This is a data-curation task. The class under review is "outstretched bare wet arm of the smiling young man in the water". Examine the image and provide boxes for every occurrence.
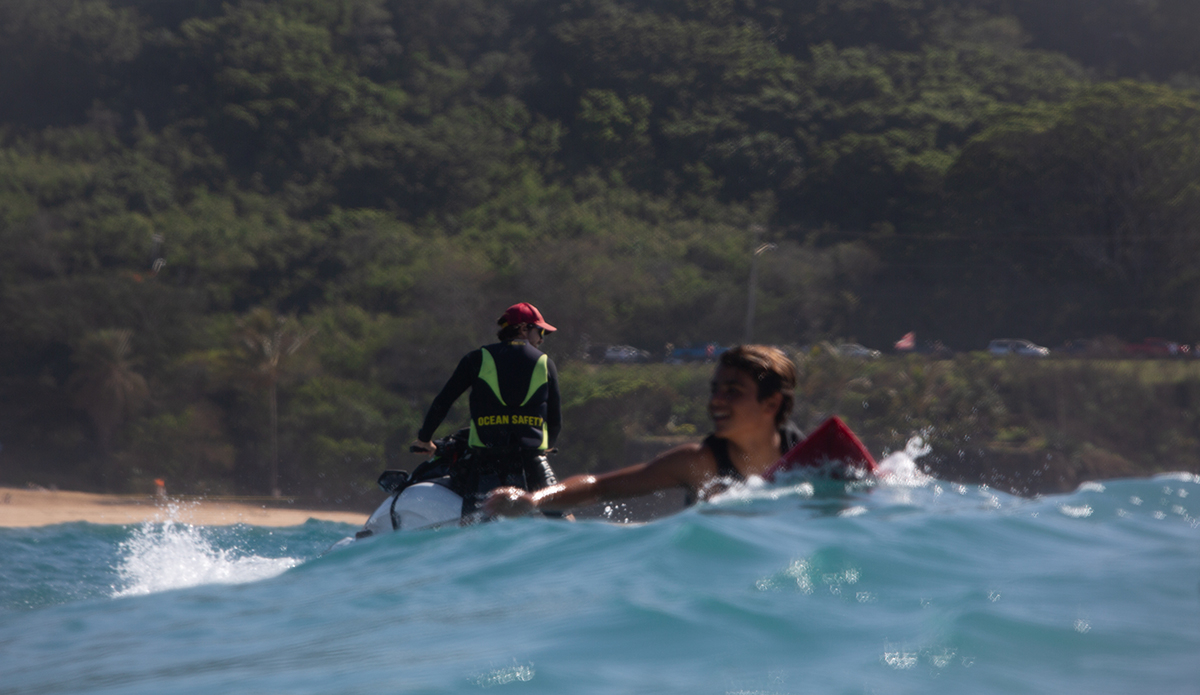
[484,444,716,516]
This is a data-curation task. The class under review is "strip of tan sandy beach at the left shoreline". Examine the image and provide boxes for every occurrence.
[0,487,366,527]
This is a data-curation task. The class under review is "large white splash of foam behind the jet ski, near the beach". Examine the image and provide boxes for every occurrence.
[113,511,300,597]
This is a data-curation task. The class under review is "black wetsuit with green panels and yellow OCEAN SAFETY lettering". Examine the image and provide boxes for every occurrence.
[416,341,563,515]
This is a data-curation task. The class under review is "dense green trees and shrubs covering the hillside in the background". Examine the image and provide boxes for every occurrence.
[0,0,1200,501]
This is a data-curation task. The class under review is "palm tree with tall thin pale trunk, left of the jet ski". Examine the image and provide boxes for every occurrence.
[238,307,317,497]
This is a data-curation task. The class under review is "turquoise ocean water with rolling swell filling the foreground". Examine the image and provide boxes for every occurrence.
[0,453,1200,695]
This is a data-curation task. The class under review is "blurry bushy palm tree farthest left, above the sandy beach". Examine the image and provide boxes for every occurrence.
[67,330,150,487]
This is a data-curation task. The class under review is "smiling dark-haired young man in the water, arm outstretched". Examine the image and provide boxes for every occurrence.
[484,344,802,516]
